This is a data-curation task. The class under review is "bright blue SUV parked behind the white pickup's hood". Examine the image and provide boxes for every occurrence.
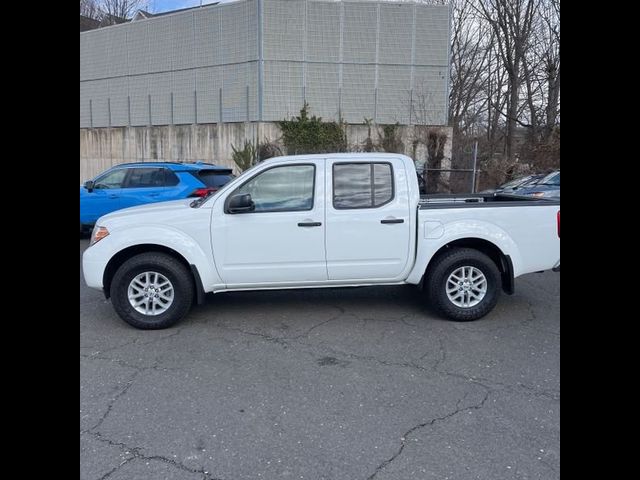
[80,162,234,232]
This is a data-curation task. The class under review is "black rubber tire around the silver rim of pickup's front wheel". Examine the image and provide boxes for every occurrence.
[111,252,194,330]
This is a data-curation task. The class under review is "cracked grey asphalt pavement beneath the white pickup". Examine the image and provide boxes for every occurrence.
[80,240,560,480]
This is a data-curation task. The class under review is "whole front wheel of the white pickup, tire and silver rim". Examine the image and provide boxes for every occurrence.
[111,252,194,330]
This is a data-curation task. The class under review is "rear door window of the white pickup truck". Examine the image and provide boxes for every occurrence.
[333,163,393,209]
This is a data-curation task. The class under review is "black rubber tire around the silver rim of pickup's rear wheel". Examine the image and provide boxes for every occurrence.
[425,248,500,322]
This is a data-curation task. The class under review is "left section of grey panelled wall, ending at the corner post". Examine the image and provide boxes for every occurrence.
[80,0,258,127]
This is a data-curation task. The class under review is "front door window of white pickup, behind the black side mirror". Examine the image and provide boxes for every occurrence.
[234,165,315,212]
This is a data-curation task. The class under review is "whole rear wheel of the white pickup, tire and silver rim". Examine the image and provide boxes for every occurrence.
[426,248,500,322]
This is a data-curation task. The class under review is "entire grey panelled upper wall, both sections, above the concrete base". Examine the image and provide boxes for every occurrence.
[80,0,449,128]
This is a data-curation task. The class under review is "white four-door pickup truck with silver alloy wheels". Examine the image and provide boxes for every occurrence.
[83,153,560,329]
